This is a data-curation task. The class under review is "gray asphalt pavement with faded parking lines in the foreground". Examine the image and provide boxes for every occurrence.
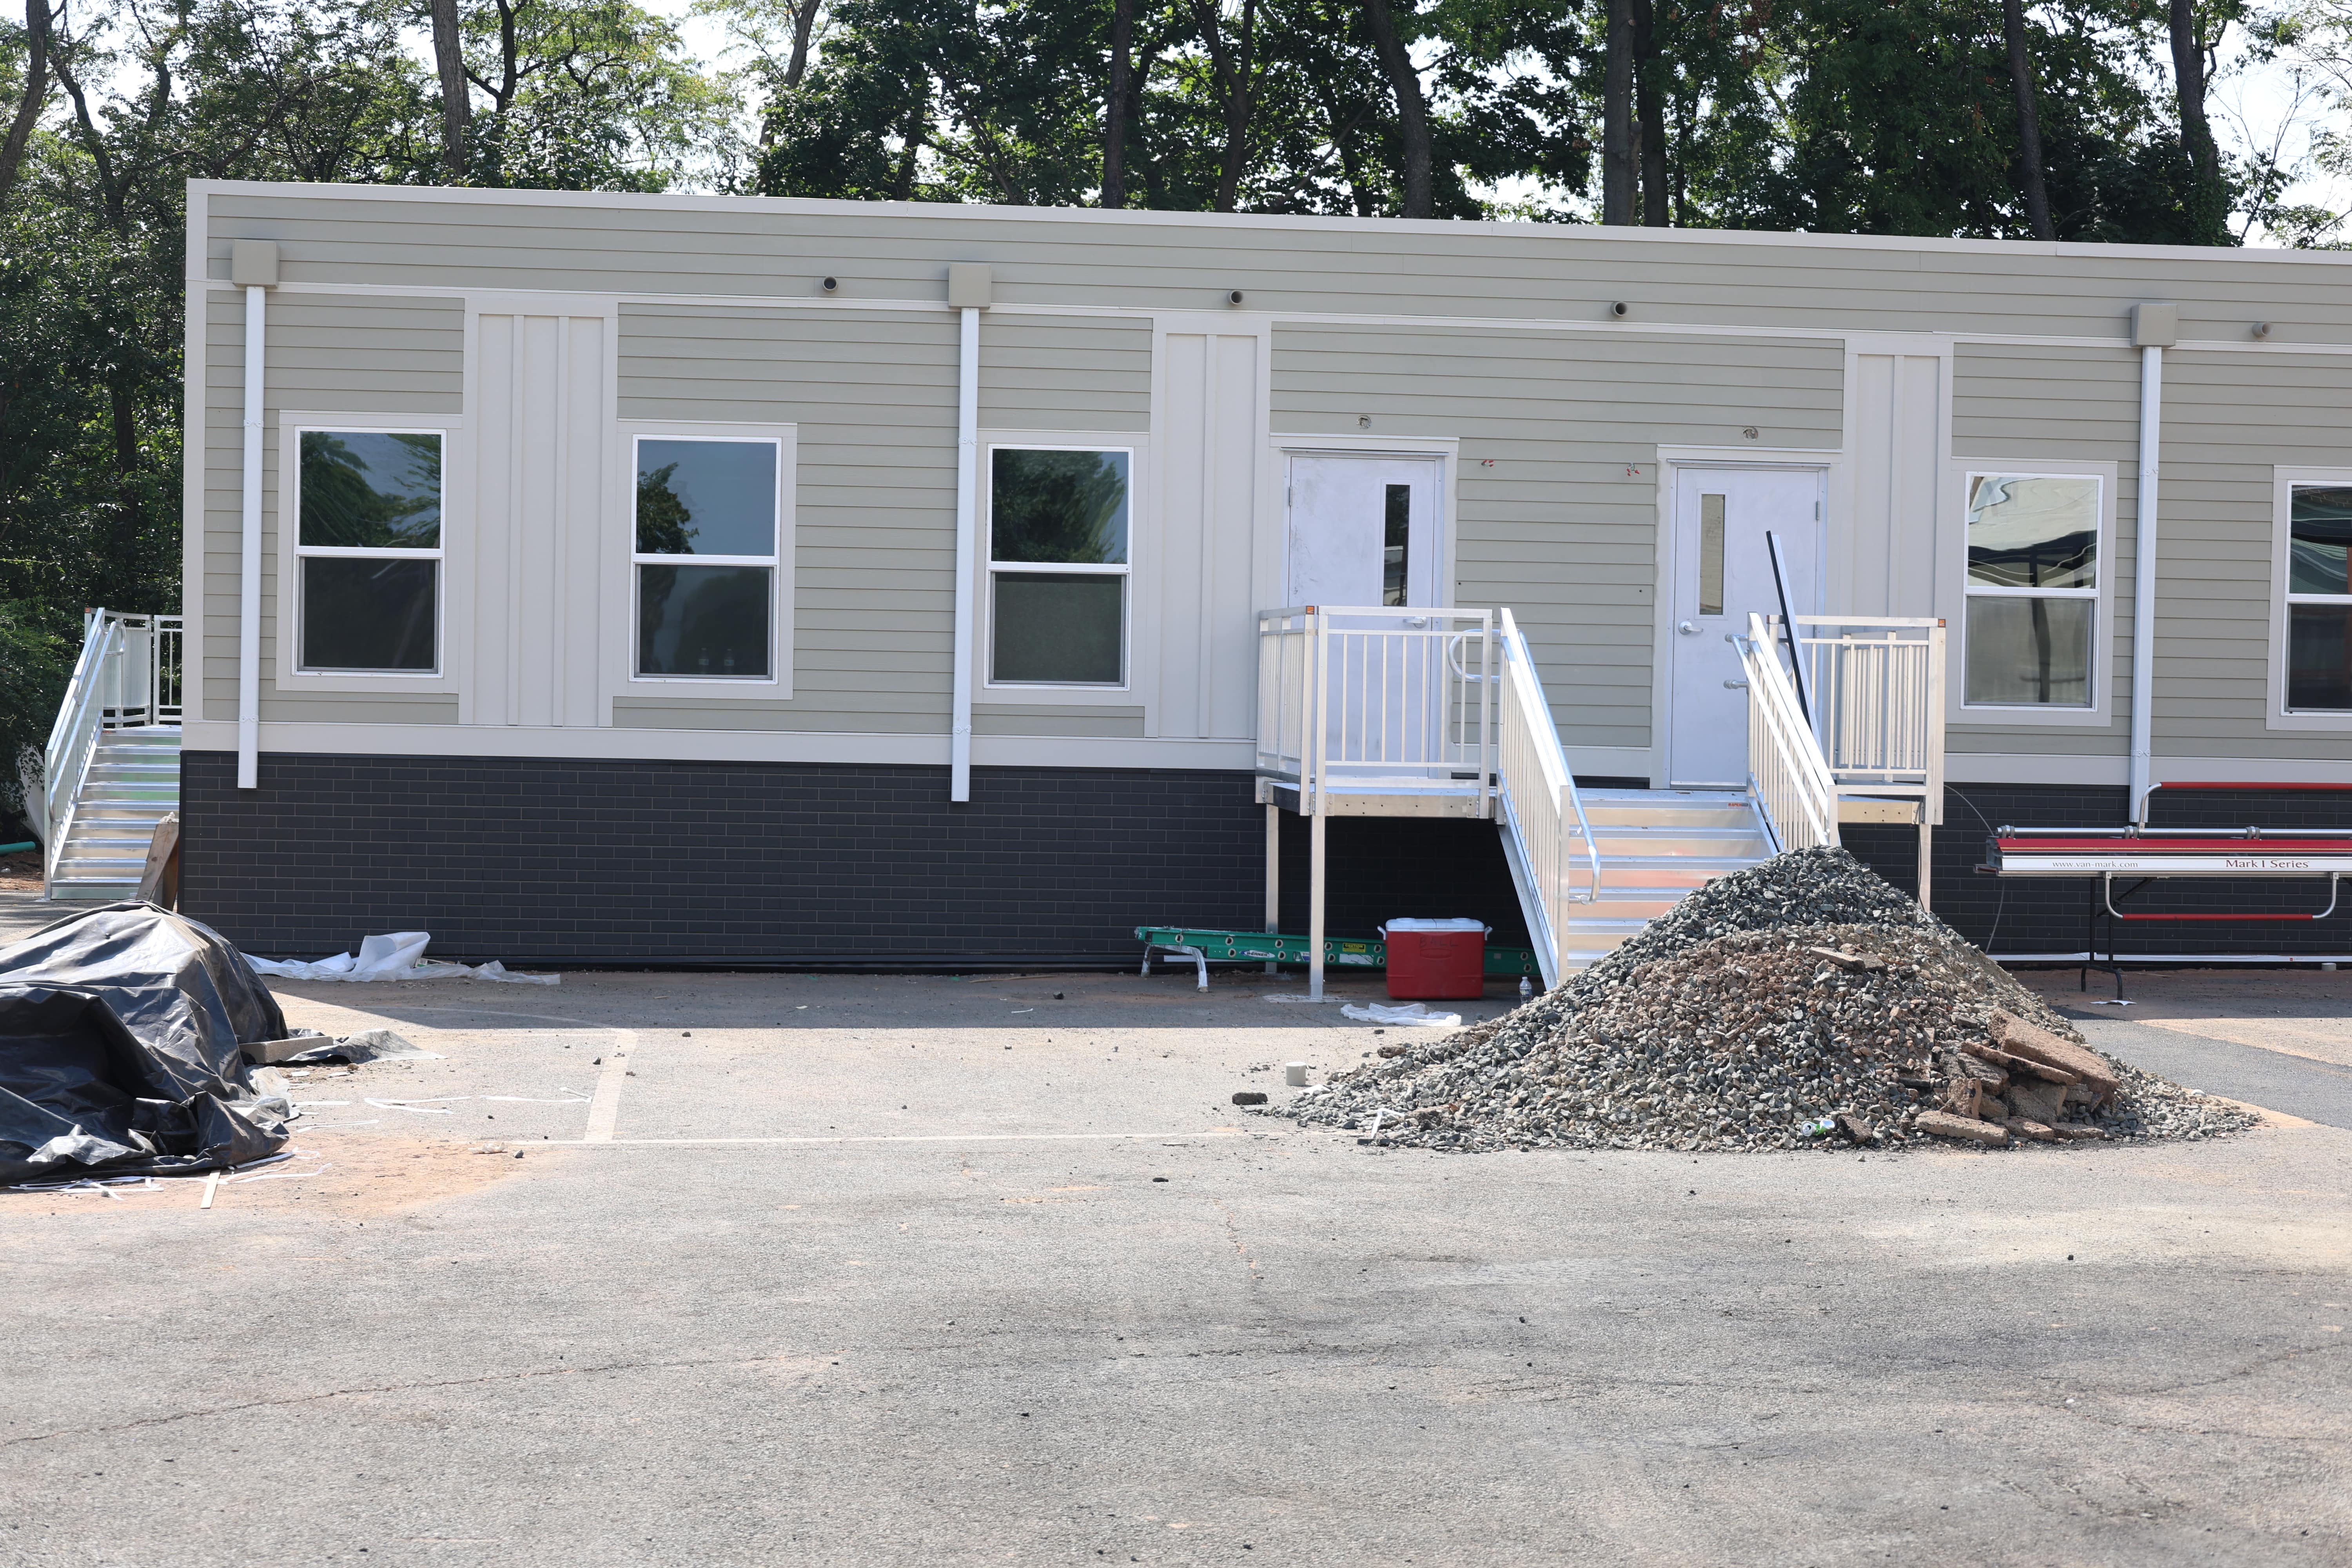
[0,973,2352,1568]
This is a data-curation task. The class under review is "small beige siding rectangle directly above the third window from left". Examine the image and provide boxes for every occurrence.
[981,313,1152,432]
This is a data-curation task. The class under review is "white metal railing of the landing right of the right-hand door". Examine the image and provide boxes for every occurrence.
[1766,616,1945,825]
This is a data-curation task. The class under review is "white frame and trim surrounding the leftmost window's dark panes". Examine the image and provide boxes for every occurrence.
[266,409,459,696]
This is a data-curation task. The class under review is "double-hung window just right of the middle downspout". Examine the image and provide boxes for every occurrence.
[988,446,1134,686]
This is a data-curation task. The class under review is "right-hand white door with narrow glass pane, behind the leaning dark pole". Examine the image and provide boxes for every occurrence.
[1665,468,1823,790]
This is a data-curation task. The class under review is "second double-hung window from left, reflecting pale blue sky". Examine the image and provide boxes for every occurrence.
[630,435,783,682]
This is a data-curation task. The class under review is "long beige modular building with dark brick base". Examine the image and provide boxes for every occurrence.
[133,181,2352,966]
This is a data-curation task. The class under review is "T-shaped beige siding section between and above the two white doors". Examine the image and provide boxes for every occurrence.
[1272,327,1844,748]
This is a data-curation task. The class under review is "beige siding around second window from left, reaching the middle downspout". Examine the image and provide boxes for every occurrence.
[614,306,960,736]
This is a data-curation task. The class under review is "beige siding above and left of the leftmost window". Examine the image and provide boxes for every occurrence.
[202,292,466,724]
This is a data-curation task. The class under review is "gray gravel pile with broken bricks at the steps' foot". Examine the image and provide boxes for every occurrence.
[1282,849,2253,1150]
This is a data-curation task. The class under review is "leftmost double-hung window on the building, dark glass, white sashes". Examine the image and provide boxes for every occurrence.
[294,430,445,675]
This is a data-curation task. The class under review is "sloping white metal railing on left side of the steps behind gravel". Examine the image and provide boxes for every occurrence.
[1496,609,1602,990]
